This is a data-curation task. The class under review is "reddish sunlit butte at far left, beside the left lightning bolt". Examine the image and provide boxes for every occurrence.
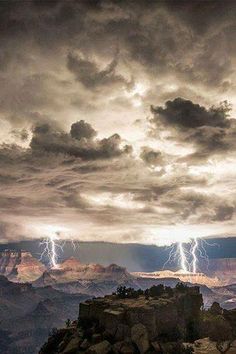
[0,250,46,282]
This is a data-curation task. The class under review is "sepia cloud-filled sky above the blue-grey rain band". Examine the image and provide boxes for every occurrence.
[0,0,236,246]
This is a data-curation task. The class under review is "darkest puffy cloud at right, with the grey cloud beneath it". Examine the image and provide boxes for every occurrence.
[149,97,236,162]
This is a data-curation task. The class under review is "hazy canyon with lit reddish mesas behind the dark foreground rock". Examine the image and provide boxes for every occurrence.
[0,250,236,354]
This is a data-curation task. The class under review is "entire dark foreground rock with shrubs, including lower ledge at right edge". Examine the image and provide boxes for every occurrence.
[40,283,236,354]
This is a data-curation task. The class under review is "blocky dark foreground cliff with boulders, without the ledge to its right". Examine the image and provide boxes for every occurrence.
[40,286,202,354]
